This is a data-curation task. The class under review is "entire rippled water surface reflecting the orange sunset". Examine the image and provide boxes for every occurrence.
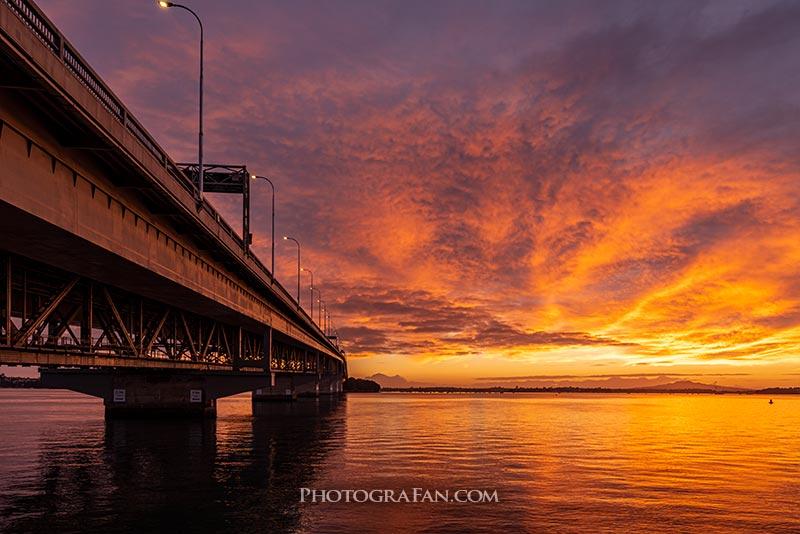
[0,390,800,533]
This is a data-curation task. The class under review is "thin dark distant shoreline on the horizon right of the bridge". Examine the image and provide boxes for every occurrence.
[381,387,800,395]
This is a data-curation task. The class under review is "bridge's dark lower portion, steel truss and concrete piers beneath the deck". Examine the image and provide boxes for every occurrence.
[0,251,342,416]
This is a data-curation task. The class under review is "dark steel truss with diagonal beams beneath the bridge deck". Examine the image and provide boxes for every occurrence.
[0,254,336,373]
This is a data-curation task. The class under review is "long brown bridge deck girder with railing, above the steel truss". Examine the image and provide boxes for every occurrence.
[0,0,344,376]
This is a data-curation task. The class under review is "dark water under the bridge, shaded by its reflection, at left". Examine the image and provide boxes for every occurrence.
[0,391,343,533]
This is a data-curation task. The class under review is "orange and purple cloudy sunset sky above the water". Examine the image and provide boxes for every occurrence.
[32,0,800,387]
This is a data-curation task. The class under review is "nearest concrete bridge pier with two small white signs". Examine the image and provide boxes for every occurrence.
[40,368,267,418]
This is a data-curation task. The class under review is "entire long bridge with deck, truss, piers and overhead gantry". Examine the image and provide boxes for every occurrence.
[0,0,347,414]
